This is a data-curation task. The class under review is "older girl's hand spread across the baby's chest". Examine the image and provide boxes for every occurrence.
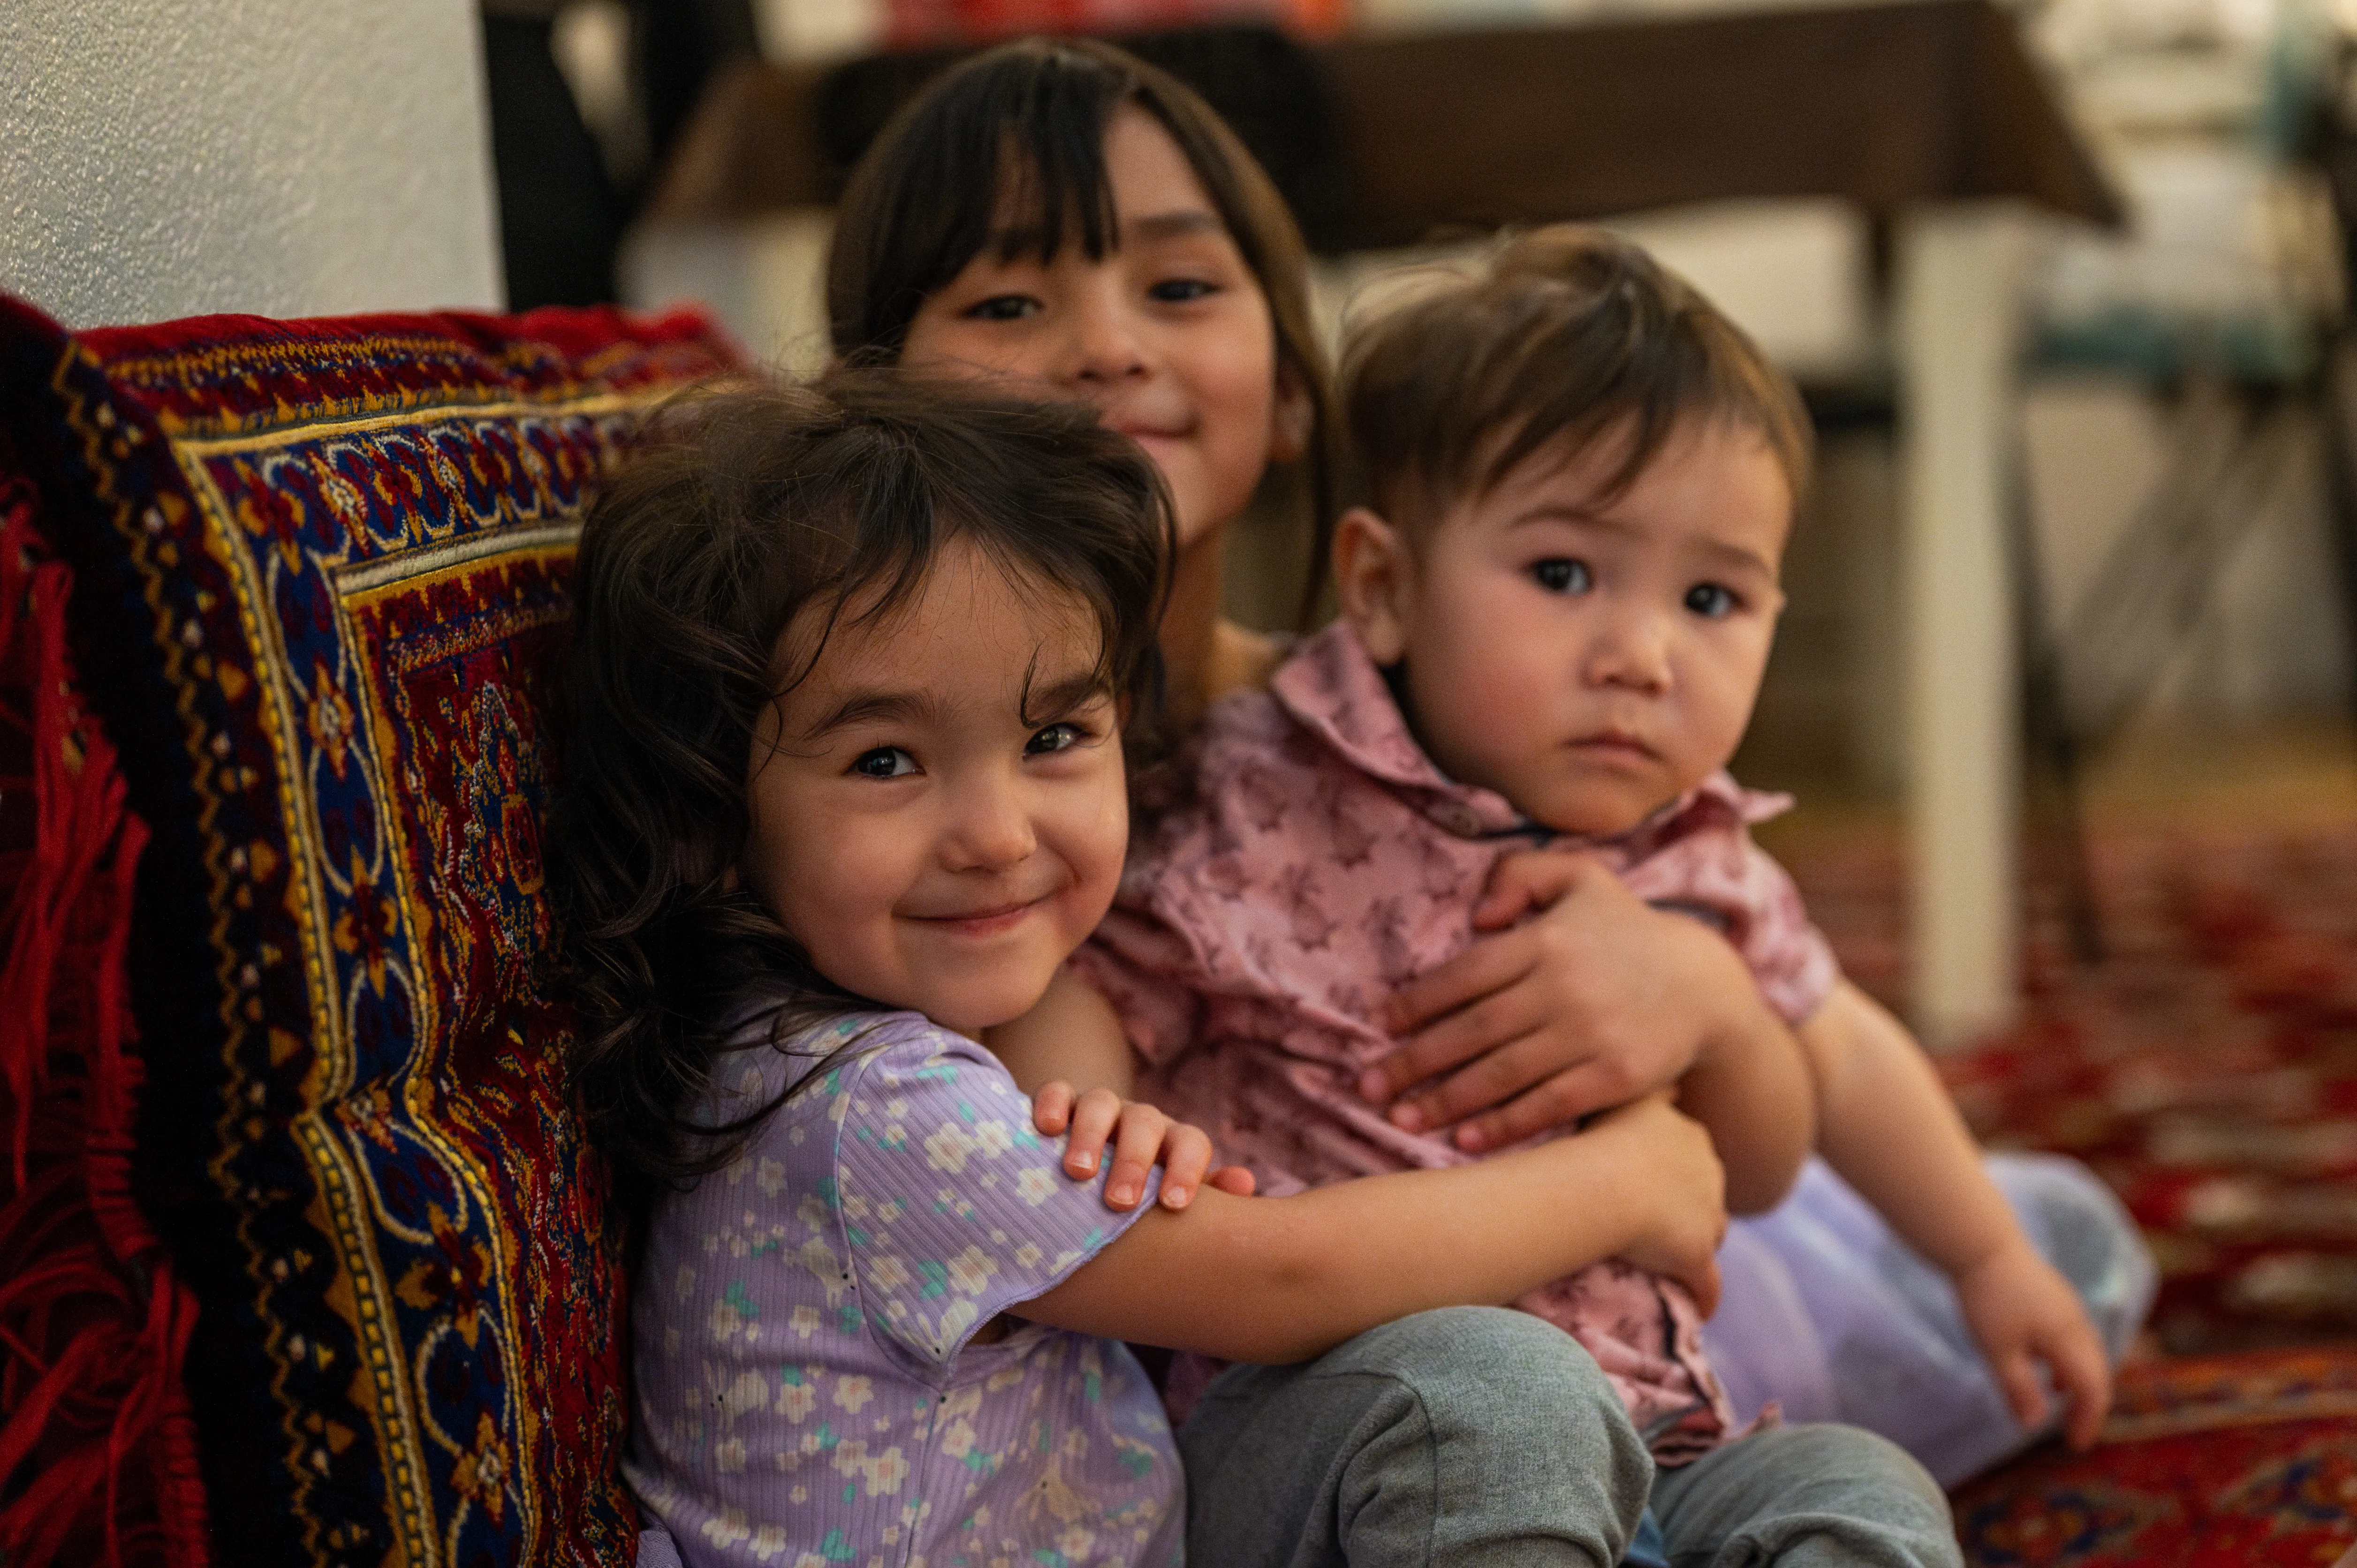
[1357,849,1761,1153]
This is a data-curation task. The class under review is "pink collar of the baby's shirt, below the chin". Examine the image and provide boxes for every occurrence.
[1268,620,1791,858]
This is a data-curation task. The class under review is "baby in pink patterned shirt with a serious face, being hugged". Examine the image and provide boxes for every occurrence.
[993,229,2109,1464]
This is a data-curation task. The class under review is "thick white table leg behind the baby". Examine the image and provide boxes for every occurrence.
[1895,205,2030,1047]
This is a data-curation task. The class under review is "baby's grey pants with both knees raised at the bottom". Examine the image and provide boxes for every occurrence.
[1179,1306,1961,1568]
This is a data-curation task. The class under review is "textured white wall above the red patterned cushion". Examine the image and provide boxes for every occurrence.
[0,0,502,328]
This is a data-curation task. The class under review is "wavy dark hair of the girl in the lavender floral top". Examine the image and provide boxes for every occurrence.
[549,370,1174,1179]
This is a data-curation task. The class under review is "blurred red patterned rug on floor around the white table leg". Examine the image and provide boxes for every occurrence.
[1791,823,2357,1354]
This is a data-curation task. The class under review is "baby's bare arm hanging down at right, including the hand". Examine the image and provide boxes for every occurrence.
[1801,981,2112,1448]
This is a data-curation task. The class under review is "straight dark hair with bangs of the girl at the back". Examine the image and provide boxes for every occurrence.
[827,38,1339,618]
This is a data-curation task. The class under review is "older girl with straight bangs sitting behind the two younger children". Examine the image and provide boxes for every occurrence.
[827,40,2152,1481]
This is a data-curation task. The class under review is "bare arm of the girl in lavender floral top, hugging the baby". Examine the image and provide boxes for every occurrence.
[1014,1097,1725,1363]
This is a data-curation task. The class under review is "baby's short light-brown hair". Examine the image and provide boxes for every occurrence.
[1343,224,1810,535]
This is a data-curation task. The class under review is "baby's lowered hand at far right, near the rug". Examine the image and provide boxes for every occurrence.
[1956,1235,2112,1448]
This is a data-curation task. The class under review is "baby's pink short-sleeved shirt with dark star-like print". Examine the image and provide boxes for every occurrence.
[1075,625,1839,1464]
